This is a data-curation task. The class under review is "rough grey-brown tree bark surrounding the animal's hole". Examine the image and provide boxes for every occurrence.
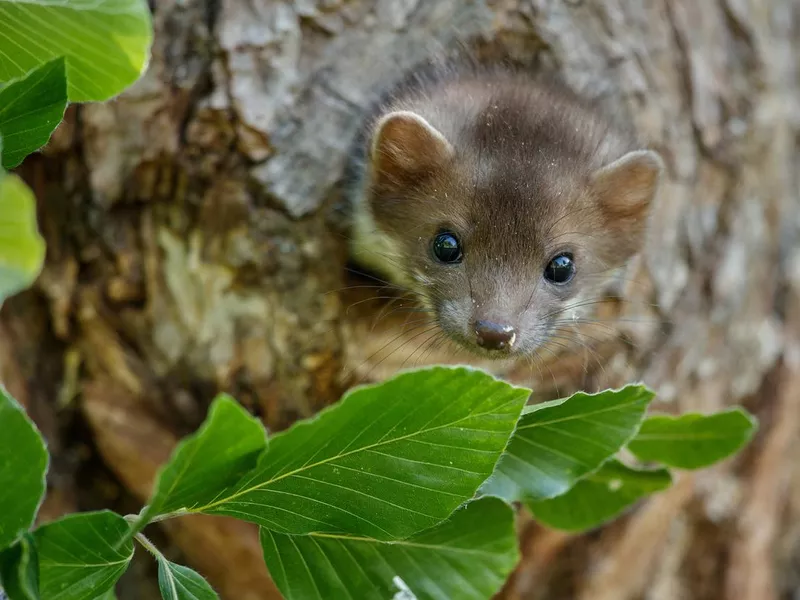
[0,0,800,600]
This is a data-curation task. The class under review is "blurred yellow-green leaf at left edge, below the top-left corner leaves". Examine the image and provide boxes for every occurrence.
[0,169,45,304]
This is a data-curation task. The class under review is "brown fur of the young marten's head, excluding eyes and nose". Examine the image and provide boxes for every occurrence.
[348,63,661,356]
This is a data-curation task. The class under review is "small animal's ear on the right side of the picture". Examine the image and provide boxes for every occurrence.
[591,150,664,221]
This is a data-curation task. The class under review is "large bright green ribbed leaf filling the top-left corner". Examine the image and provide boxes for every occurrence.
[0,0,153,102]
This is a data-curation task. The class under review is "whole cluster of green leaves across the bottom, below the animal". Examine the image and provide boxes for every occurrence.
[0,367,754,600]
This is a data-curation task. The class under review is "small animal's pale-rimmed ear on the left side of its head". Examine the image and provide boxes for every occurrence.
[370,111,454,184]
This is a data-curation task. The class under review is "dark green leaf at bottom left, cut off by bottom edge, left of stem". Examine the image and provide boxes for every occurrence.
[33,511,133,600]
